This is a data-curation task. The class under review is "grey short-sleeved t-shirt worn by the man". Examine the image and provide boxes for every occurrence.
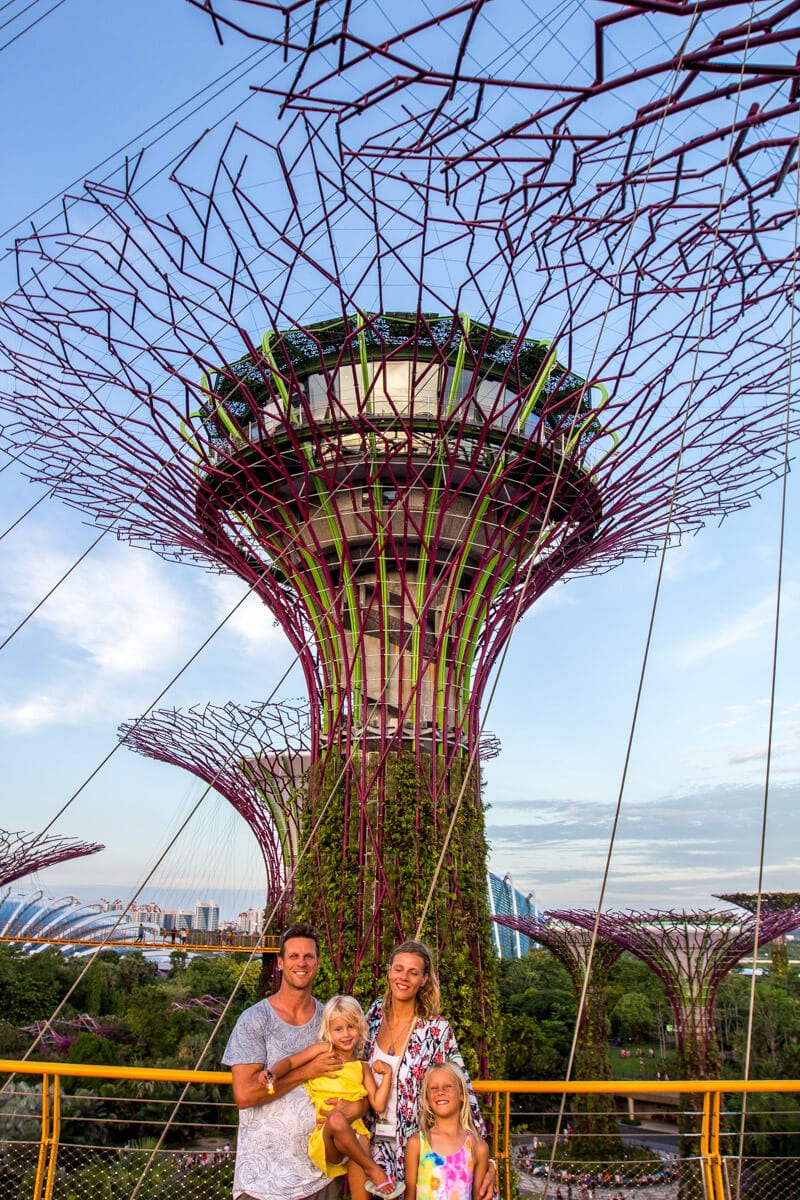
[222,1000,327,1200]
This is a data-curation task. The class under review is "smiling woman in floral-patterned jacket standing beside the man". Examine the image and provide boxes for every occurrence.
[357,942,497,1200]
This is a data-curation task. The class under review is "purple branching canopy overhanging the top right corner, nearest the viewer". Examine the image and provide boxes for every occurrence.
[195,0,800,229]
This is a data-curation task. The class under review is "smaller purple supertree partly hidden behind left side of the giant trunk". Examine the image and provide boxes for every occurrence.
[120,702,309,924]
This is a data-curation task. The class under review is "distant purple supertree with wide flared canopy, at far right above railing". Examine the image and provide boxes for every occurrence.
[551,908,800,1079]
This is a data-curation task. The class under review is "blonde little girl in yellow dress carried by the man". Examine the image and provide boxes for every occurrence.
[259,996,403,1200]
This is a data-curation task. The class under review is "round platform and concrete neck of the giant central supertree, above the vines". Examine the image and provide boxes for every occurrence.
[197,313,601,757]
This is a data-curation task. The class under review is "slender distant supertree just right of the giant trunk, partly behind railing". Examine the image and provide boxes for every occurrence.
[492,913,622,1159]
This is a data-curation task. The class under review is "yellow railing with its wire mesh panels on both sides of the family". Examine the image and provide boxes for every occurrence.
[0,1060,800,1200]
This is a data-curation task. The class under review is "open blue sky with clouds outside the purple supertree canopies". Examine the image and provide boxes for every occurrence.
[0,0,800,907]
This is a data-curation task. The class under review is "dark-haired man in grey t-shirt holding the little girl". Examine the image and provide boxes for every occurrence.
[222,925,357,1200]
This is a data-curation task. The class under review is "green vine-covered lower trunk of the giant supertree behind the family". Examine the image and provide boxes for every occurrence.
[295,750,498,1073]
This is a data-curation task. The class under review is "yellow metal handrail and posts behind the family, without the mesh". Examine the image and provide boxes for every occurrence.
[0,1060,800,1200]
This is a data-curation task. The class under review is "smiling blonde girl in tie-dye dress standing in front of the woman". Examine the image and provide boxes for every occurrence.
[405,1062,489,1200]
